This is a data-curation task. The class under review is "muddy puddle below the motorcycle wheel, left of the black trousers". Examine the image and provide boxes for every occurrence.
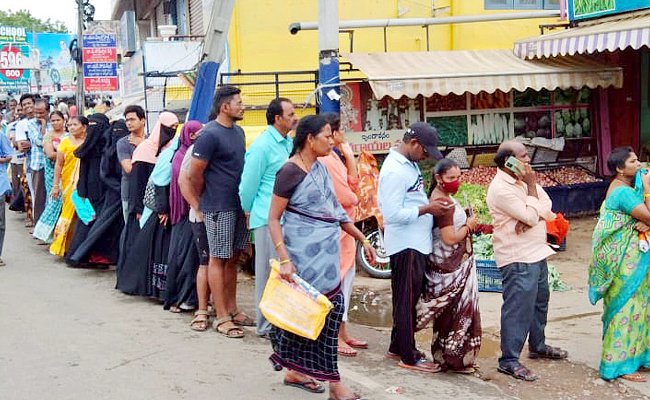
[348,288,393,328]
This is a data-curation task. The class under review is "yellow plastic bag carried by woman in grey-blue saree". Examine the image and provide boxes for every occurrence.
[259,259,333,340]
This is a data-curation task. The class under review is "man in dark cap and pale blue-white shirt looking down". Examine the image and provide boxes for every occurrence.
[378,122,452,372]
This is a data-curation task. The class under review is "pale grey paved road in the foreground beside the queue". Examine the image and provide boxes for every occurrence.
[0,212,508,400]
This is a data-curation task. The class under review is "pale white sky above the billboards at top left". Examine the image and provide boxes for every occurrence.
[10,0,112,33]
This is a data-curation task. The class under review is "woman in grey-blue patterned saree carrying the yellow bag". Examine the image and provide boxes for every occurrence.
[268,115,375,400]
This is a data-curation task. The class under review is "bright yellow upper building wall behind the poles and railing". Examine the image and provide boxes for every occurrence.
[229,0,558,125]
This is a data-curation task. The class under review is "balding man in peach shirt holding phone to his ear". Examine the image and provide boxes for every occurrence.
[487,141,568,381]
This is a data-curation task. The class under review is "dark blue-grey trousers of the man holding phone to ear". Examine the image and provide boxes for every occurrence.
[499,260,549,367]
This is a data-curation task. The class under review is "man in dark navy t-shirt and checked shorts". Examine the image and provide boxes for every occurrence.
[189,85,255,338]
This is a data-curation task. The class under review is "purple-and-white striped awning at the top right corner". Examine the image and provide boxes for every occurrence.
[514,12,650,59]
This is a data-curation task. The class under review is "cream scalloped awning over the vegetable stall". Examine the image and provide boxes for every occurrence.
[343,50,623,99]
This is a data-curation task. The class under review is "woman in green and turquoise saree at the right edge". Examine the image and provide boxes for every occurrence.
[589,147,650,382]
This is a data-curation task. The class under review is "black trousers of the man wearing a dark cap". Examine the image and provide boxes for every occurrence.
[388,249,429,365]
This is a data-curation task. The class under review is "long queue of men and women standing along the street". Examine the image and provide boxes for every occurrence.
[5,85,650,399]
